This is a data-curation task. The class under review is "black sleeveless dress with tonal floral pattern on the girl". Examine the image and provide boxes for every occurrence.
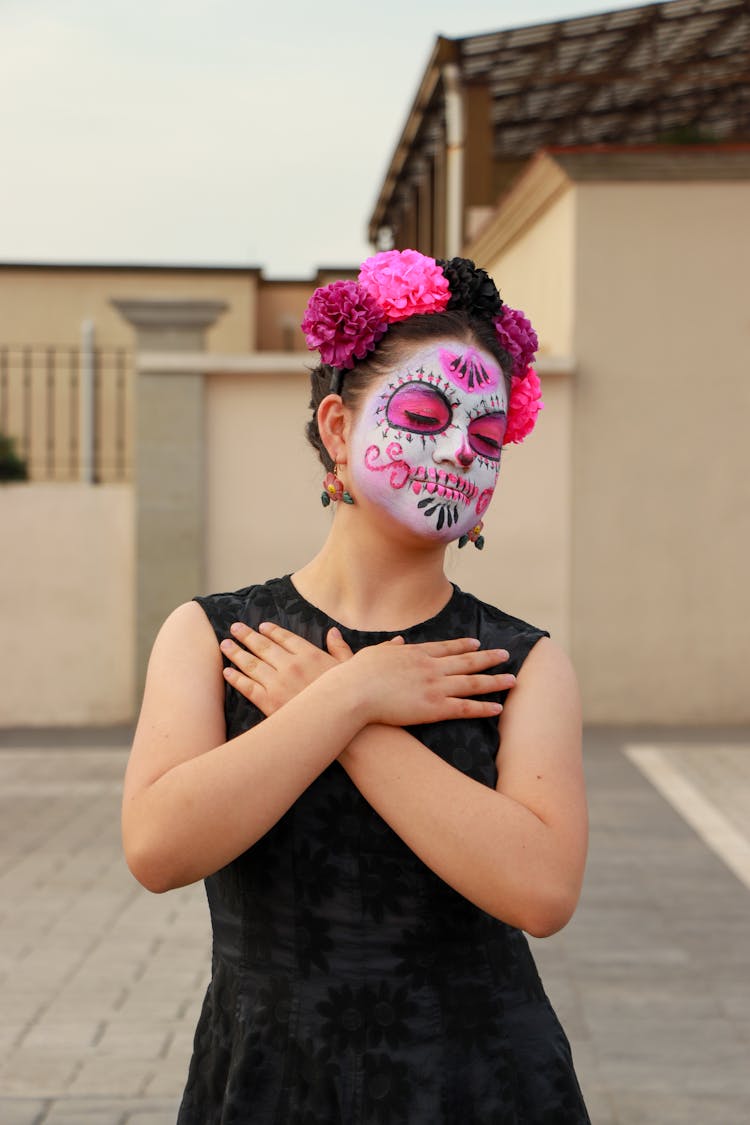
[178,576,589,1125]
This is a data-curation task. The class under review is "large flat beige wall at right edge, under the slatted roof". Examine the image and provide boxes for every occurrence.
[572,175,750,723]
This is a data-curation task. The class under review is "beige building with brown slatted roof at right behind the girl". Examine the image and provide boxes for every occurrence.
[370,0,750,723]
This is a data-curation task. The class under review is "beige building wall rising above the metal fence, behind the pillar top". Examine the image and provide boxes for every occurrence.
[0,267,257,352]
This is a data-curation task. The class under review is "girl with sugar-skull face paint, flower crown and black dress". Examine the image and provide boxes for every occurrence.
[123,251,588,1125]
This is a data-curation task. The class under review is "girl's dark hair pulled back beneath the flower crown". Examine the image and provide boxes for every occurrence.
[305,308,513,473]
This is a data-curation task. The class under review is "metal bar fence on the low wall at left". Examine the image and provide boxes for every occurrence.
[0,344,134,484]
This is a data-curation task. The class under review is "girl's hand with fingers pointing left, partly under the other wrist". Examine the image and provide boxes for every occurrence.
[219,621,352,717]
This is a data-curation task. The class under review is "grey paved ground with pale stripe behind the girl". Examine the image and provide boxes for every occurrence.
[0,730,750,1125]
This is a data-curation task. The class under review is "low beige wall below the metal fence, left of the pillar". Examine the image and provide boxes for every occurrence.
[0,484,134,727]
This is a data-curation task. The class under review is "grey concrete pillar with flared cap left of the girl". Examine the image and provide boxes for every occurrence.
[111,299,227,694]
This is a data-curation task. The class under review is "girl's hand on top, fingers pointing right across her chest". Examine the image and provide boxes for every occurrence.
[336,637,515,727]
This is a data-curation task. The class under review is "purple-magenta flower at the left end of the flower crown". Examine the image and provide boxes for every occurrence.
[302,281,388,368]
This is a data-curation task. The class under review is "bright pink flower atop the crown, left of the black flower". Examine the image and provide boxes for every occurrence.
[359,250,451,324]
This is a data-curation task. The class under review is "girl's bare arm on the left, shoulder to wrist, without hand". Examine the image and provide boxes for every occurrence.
[123,603,361,891]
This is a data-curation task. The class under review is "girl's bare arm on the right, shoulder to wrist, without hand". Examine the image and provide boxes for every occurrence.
[340,640,587,937]
